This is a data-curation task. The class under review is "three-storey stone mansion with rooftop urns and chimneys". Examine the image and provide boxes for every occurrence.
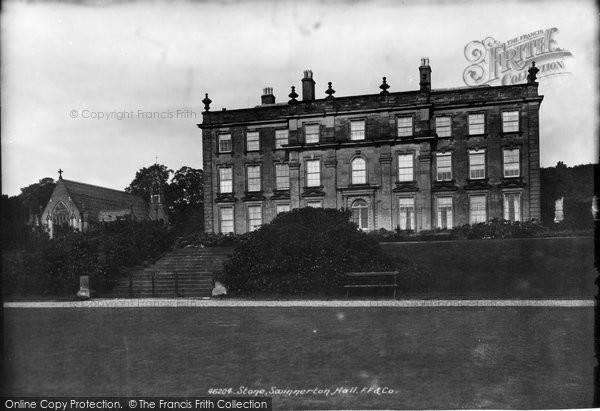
[198,59,543,234]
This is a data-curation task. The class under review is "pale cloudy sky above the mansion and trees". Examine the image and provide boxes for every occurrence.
[0,0,599,195]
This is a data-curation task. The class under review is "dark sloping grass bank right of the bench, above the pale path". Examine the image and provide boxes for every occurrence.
[382,237,598,299]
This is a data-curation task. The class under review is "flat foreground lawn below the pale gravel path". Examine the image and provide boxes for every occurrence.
[3,307,594,409]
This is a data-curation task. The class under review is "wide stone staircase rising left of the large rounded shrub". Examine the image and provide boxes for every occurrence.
[101,247,233,298]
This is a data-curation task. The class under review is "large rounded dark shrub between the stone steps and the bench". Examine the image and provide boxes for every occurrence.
[222,208,410,295]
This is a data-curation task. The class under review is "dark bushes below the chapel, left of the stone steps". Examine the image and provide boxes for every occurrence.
[3,221,173,295]
